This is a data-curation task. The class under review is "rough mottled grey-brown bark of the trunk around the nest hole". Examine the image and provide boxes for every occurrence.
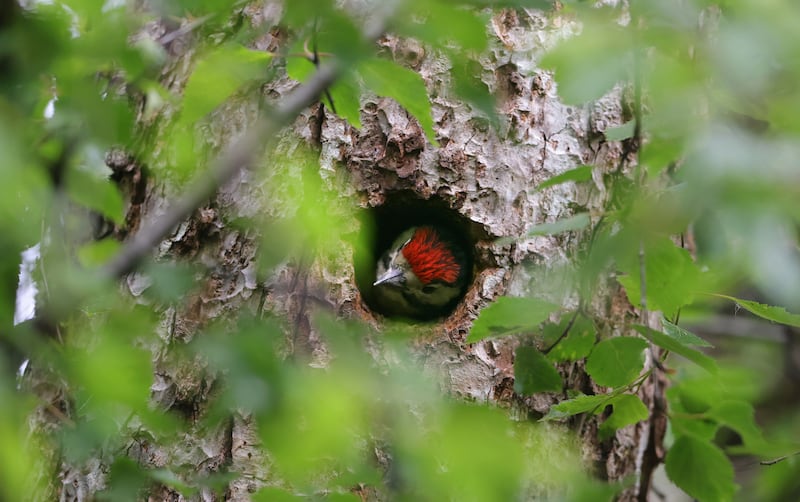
[54,4,663,500]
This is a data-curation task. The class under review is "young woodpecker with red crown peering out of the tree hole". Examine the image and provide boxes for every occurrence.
[372,225,470,319]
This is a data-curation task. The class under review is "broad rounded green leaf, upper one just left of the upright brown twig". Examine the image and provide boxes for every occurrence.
[586,336,647,387]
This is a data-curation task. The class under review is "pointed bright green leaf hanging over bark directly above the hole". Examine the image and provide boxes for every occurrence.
[358,58,438,146]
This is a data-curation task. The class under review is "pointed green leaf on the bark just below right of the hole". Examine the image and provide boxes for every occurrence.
[467,296,559,343]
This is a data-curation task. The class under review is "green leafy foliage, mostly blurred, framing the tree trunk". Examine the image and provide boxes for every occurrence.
[0,0,800,501]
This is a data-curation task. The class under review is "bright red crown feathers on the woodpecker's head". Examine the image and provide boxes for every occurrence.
[403,227,461,284]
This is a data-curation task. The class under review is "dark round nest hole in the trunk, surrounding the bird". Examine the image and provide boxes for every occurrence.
[354,191,484,321]
